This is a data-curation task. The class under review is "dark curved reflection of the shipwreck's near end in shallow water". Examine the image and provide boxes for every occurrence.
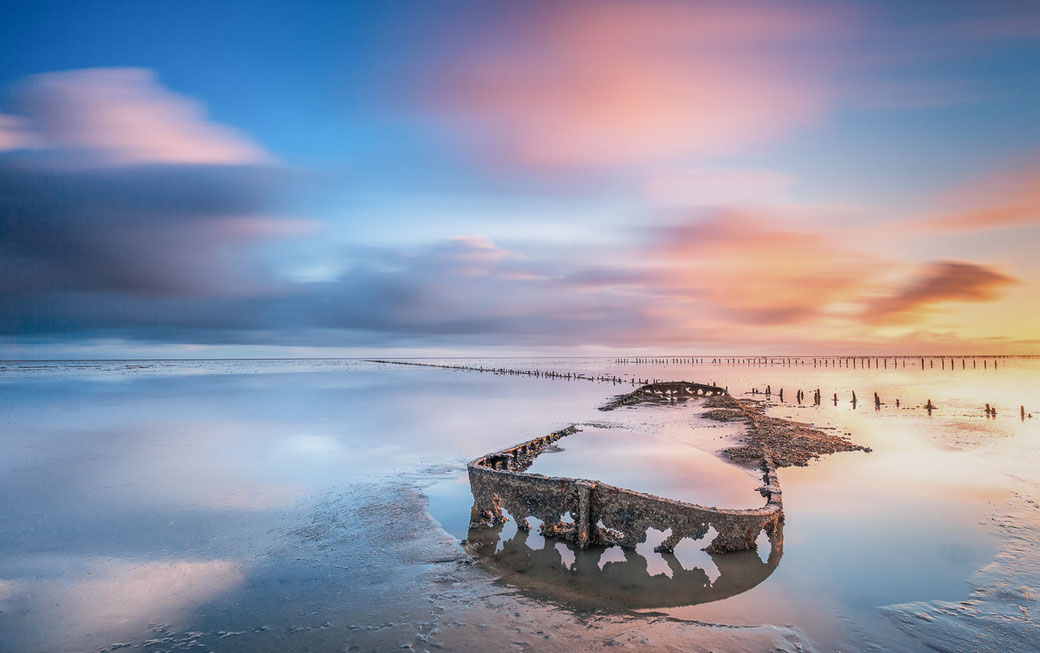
[466,515,783,610]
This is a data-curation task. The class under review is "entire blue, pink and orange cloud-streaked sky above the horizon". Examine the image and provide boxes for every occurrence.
[0,0,1040,359]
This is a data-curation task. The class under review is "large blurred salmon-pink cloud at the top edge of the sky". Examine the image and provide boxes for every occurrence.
[430,1,843,168]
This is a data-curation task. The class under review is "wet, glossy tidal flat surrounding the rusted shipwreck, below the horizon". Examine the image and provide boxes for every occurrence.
[0,358,1040,651]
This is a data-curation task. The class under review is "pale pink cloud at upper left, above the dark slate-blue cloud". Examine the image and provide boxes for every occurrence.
[0,68,272,165]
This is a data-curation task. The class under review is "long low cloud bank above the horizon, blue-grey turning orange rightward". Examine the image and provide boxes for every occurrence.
[0,210,1012,347]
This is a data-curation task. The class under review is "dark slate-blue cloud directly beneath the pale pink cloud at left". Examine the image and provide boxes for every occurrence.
[0,162,289,295]
